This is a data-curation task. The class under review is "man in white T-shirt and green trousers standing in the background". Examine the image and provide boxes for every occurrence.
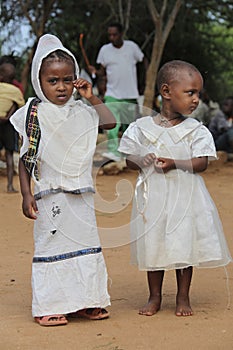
[88,23,146,161]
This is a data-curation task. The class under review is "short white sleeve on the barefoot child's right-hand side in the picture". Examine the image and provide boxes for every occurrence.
[191,125,217,160]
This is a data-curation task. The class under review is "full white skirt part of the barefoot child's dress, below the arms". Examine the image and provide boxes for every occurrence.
[131,170,232,271]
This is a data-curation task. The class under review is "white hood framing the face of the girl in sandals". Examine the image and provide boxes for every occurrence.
[31,34,79,102]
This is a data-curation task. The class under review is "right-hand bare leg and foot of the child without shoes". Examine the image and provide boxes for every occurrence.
[176,266,193,316]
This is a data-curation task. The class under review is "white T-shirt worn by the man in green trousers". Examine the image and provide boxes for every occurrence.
[96,40,144,99]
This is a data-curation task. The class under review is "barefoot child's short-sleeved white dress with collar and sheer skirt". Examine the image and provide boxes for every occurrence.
[119,117,232,271]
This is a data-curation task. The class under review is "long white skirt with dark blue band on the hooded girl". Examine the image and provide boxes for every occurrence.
[32,193,110,317]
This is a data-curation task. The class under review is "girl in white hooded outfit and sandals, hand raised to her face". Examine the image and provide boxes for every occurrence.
[11,34,115,326]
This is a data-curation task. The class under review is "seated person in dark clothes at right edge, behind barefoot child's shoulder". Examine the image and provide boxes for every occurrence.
[208,96,233,153]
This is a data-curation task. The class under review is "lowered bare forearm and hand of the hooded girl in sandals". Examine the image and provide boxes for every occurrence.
[19,159,38,220]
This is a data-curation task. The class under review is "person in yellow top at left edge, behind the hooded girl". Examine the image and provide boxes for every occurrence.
[0,63,25,193]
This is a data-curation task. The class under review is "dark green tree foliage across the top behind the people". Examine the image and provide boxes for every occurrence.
[0,0,233,101]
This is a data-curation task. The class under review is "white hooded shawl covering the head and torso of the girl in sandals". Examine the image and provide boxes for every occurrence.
[11,34,99,188]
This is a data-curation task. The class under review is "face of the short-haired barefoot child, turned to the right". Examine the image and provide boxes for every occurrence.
[169,71,203,115]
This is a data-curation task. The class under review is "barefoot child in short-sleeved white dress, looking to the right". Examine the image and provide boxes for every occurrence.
[119,60,232,316]
